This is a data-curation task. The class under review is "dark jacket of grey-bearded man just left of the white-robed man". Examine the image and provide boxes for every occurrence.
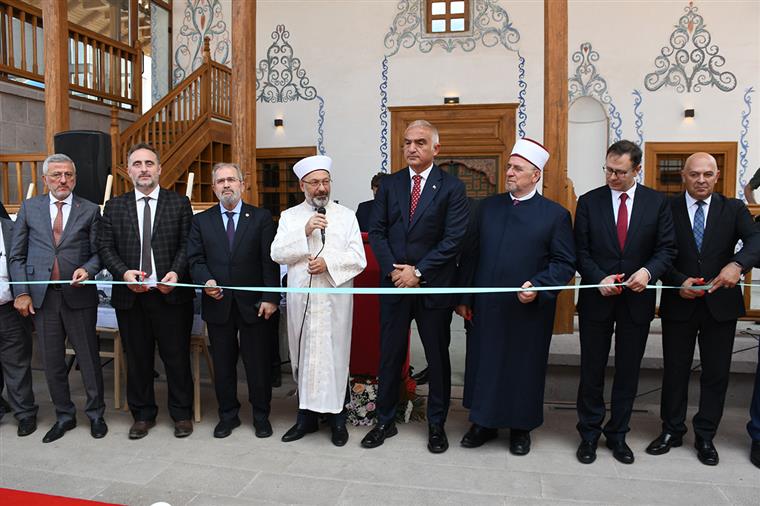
[187,203,280,324]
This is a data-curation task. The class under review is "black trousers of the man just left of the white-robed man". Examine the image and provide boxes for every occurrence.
[206,301,279,422]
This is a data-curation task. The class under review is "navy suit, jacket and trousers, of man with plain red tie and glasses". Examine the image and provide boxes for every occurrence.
[575,185,676,441]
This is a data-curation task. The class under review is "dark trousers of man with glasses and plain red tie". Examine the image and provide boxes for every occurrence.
[577,301,649,441]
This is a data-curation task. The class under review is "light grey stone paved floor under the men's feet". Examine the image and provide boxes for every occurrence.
[0,371,760,506]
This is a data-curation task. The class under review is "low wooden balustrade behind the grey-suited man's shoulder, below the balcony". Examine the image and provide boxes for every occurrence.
[0,153,47,213]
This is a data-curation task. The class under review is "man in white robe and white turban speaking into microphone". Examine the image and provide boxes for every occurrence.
[271,156,367,446]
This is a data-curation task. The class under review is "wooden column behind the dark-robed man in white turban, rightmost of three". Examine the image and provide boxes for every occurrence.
[543,0,575,334]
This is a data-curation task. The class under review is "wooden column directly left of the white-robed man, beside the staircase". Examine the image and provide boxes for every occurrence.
[231,0,259,205]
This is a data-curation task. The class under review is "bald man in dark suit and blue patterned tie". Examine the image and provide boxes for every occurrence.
[646,153,760,466]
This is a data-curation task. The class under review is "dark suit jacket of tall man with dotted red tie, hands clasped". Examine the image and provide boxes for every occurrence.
[369,165,468,308]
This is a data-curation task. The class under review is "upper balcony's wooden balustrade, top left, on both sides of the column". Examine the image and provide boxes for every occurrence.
[0,0,142,111]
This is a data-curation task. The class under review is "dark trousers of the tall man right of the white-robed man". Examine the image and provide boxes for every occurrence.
[377,295,452,425]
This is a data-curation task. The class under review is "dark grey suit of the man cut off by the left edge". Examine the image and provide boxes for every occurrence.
[0,217,37,420]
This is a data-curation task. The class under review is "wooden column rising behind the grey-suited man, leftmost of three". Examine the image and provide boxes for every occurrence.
[42,0,69,153]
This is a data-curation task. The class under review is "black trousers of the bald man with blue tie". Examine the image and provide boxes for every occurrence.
[660,300,736,441]
